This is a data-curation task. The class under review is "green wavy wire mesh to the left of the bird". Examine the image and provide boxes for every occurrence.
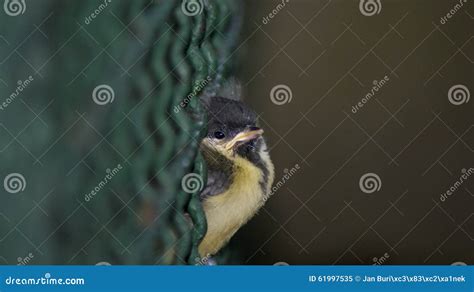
[0,0,241,264]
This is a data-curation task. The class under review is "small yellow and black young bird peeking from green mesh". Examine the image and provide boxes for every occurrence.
[198,79,275,258]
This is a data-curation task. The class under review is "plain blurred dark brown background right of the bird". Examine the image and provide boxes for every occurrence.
[232,0,474,265]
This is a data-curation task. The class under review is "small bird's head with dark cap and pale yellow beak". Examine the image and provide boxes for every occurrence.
[202,97,264,162]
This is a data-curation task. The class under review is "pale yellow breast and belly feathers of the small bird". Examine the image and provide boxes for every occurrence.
[199,147,274,257]
